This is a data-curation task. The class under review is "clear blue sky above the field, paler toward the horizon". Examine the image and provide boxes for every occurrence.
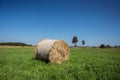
[0,0,120,46]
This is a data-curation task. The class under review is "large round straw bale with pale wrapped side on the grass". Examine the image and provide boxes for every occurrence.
[35,39,70,64]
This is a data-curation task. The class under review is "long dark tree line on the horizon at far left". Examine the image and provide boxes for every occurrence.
[0,42,32,46]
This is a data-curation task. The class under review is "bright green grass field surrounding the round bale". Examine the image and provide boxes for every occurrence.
[0,47,120,80]
